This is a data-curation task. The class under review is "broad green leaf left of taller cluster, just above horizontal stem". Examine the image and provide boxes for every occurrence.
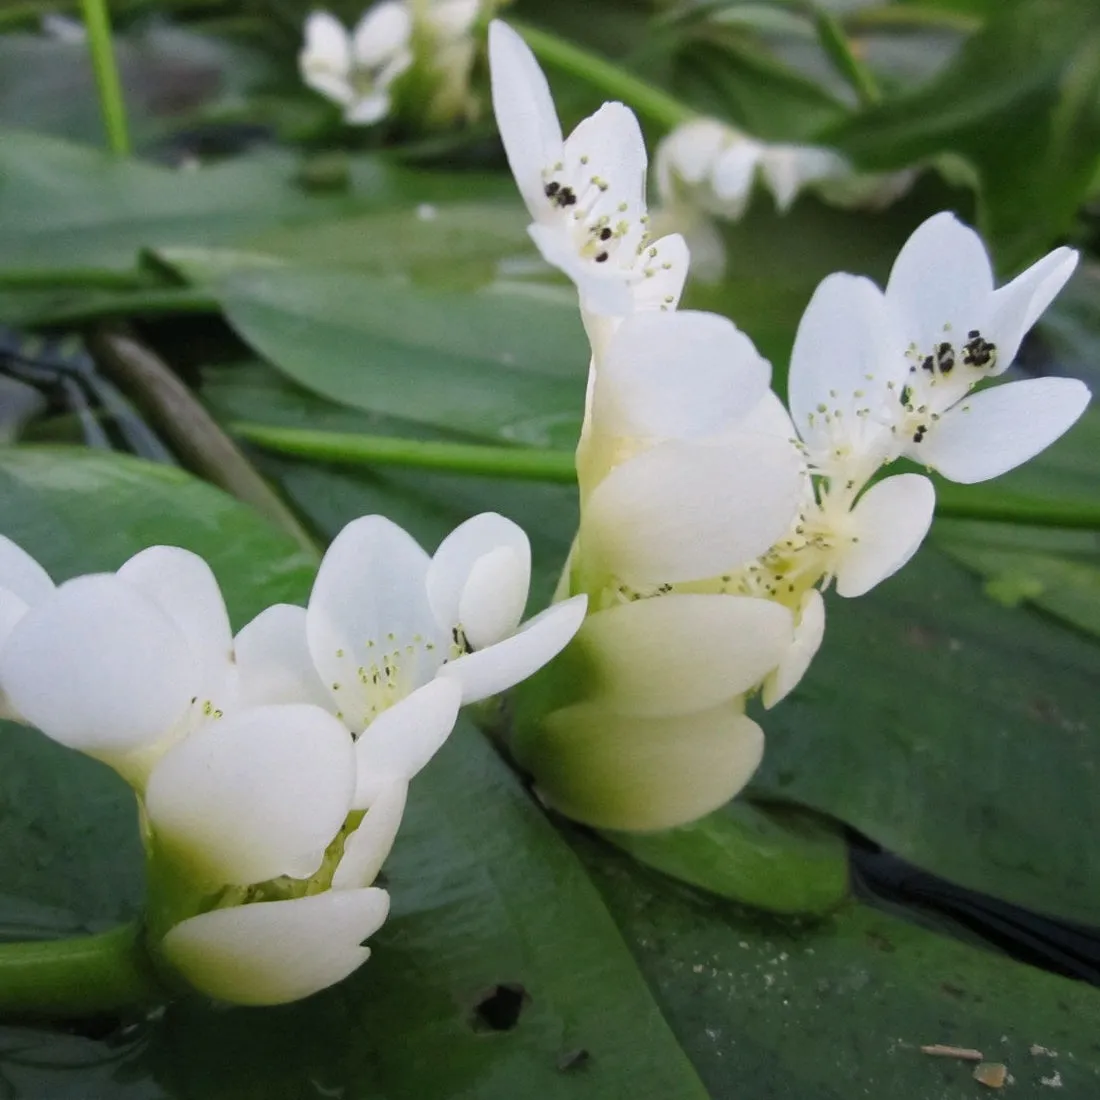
[219,270,589,447]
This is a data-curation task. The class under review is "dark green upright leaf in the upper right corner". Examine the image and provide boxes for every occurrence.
[820,0,1100,272]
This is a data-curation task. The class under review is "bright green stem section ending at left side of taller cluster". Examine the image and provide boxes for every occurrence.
[236,421,576,485]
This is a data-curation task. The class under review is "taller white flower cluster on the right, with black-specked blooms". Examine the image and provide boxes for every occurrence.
[490,23,1089,831]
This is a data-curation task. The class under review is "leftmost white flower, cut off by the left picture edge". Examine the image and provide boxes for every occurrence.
[0,540,243,790]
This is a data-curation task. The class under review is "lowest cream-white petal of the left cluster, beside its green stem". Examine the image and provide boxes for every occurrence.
[161,888,389,1004]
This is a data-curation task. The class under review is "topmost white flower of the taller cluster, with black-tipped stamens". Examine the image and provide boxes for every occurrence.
[490,21,688,317]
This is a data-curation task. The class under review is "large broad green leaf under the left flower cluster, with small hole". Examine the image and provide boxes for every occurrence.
[0,448,705,1100]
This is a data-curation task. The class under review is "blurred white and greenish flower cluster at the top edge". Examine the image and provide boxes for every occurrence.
[298,0,493,125]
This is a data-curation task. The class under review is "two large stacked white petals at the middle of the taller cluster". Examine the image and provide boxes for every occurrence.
[573,312,802,607]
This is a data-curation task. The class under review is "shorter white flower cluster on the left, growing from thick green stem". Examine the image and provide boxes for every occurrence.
[0,513,585,1004]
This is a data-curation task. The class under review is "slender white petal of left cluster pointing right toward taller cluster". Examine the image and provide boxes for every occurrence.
[440,596,587,705]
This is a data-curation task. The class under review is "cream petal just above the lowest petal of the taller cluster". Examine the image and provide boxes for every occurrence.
[575,595,792,717]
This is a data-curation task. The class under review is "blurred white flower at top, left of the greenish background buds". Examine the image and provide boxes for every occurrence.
[298,0,413,125]
